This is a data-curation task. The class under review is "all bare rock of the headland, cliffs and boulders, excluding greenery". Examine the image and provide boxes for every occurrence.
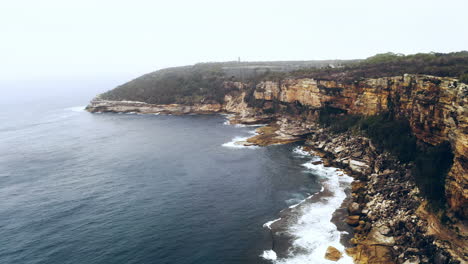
[87,53,468,264]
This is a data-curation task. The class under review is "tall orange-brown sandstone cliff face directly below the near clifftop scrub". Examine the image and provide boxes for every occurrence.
[245,75,468,216]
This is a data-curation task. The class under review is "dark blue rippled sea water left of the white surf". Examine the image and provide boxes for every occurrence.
[0,87,320,264]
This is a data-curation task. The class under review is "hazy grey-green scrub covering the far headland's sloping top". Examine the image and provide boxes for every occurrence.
[101,60,356,105]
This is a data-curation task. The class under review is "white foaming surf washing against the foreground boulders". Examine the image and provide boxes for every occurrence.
[262,147,353,264]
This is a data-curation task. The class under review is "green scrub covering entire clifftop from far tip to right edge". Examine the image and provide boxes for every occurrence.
[101,51,468,104]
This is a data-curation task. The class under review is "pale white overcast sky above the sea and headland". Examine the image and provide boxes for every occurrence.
[0,0,468,81]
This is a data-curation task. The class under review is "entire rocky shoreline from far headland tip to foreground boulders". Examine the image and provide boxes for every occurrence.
[87,100,468,264]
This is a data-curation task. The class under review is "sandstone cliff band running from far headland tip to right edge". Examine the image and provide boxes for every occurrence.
[87,74,468,217]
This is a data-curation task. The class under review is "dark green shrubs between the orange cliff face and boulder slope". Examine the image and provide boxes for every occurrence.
[319,108,453,205]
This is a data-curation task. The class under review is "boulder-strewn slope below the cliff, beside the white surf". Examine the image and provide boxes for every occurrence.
[305,128,467,264]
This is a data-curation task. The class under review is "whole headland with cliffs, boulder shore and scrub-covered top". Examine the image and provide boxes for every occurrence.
[87,51,468,264]
